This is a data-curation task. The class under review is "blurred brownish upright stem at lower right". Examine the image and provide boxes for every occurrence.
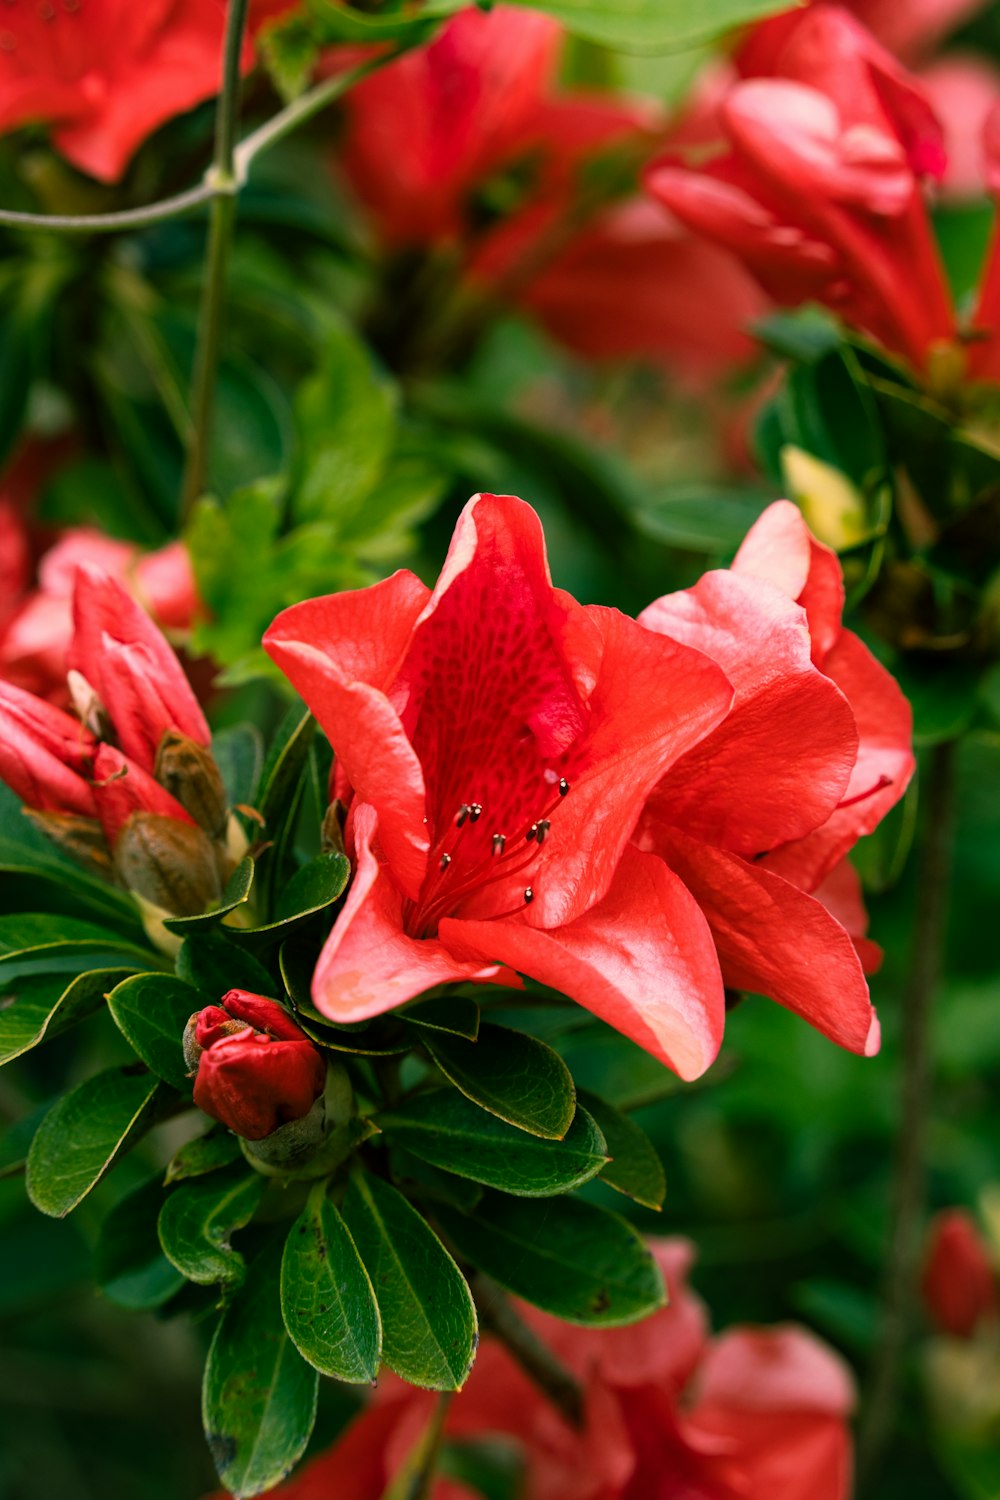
[858,741,955,1496]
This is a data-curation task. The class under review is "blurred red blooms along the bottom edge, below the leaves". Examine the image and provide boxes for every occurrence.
[254,1241,855,1500]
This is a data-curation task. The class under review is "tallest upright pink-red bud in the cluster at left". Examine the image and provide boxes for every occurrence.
[67,567,211,771]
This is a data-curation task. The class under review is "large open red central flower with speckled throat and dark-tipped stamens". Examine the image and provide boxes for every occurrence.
[264,495,730,1077]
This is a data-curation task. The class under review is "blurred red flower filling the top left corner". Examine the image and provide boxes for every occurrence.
[0,0,250,182]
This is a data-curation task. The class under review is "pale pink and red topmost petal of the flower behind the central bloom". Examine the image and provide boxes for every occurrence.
[732,500,844,666]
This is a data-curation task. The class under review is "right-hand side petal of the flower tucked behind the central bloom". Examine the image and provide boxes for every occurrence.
[765,630,915,891]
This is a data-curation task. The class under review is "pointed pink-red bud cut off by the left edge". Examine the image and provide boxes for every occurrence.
[0,683,97,818]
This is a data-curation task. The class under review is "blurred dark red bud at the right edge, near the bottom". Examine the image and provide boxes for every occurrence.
[921,1209,1000,1338]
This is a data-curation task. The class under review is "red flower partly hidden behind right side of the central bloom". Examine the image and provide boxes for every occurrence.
[637,501,913,1053]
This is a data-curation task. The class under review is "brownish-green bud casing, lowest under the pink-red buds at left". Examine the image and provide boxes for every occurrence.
[114,813,222,917]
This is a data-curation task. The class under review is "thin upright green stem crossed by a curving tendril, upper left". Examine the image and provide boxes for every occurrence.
[181,0,249,521]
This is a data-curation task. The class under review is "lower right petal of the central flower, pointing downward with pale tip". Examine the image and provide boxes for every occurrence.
[439,846,724,1079]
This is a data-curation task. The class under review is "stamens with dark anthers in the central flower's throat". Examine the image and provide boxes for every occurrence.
[403,770,570,938]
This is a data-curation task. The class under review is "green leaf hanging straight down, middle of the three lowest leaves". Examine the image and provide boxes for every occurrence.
[282,1182,382,1385]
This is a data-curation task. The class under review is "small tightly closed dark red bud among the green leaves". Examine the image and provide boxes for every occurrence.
[184,990,327,1140]
